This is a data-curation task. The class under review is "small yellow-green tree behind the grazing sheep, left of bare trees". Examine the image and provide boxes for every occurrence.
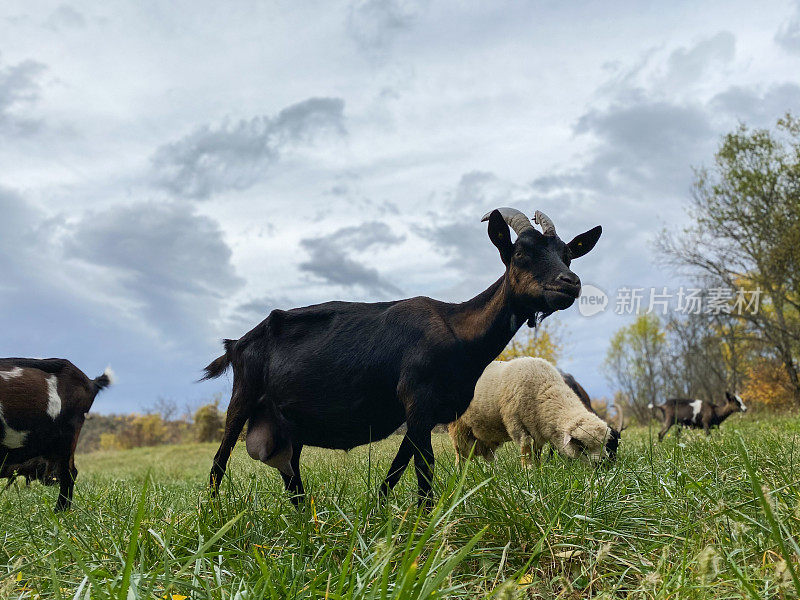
[604,314,666,423]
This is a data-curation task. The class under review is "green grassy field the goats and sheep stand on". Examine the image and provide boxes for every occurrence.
[0,415,800,600]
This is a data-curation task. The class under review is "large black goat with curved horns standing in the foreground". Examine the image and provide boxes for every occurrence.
[203,208,602,504]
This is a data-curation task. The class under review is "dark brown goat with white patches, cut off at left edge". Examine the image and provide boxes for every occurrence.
[0,358,114,510]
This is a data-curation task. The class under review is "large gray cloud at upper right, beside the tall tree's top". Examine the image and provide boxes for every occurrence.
[532,31,800,200]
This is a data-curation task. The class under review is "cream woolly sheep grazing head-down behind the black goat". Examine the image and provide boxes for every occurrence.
[448,356,611,465]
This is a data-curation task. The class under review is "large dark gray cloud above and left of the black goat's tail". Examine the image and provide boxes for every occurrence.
[64,202,243,343]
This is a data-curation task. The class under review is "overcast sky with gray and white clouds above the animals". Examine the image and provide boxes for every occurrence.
[0,0,800,412]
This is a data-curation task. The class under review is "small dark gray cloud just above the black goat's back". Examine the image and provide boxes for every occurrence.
[300,221,405,296]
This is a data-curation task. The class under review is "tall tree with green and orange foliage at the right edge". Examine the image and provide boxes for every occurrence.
[657,114,800,407]
